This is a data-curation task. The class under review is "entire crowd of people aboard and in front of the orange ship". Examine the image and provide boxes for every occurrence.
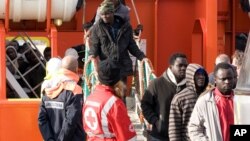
[6,0,248,141]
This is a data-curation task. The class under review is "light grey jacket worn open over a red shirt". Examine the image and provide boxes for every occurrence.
[188,89,223,141]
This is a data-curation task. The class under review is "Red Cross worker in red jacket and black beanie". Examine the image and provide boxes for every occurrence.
[82,59,136,141]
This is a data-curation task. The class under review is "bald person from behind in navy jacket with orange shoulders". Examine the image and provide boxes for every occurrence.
[38,56,85,141]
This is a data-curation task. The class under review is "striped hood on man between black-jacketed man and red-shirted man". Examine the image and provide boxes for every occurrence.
[186,64,208,91]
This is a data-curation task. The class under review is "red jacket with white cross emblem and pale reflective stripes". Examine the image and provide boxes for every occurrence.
[82,85,136,141]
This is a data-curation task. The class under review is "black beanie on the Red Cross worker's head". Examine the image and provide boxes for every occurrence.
[98,59,121,86]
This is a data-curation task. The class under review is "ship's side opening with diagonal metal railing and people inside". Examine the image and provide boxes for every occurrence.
[6,34,49,98]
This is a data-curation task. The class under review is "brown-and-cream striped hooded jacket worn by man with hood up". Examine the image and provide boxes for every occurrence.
[168,64,208,141]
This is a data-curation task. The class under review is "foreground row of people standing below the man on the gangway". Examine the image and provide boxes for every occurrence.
[36,48,244,141]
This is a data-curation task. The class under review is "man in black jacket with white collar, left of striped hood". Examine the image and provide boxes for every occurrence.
[141,53,188,141]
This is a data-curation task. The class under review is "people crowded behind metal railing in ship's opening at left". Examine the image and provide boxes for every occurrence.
[6,40,47,98]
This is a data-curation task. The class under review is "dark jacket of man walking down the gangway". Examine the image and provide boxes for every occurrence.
[89,16,145,77]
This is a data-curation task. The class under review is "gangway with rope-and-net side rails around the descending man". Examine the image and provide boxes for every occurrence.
[83,34,156,141]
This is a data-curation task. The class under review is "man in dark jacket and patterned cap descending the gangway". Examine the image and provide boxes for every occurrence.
[89,1,146,102]
